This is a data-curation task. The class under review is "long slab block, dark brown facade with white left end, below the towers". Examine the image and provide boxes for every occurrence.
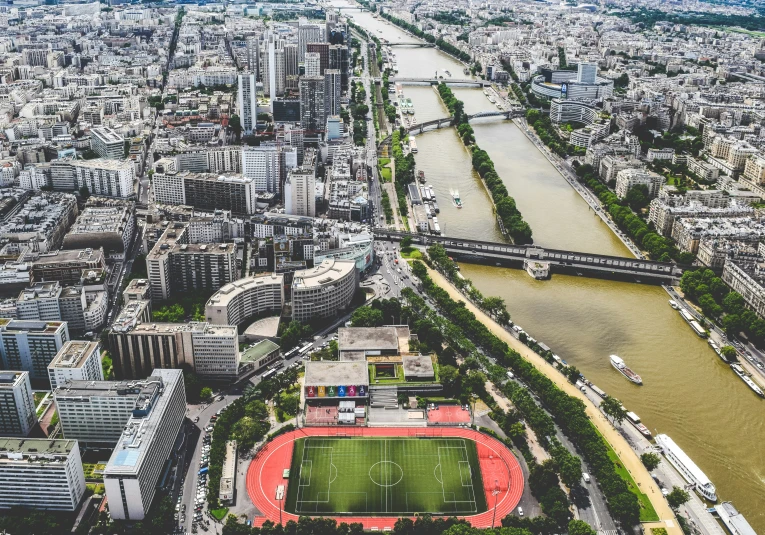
[153,169,258,214]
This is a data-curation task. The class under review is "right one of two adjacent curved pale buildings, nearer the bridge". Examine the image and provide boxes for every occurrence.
[292,259,358,322]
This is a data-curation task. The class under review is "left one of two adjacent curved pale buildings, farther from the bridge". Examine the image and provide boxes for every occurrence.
[205,273,284,326]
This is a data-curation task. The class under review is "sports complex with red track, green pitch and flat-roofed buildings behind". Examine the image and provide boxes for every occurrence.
[246,327,524,531]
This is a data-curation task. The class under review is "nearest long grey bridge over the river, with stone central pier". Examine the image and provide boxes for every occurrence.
[374,229,683,283]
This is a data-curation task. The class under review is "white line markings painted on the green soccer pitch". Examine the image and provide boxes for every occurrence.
[295,438,478,514]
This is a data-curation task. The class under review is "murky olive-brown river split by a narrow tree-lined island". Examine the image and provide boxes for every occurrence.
[337,0,765,533]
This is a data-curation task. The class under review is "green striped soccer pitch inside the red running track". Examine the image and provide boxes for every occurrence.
[285,437,486,515]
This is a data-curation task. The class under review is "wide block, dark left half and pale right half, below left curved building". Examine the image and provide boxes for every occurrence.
[109,320,240,380]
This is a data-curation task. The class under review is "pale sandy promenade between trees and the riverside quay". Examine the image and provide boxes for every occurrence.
[428,268,682,535]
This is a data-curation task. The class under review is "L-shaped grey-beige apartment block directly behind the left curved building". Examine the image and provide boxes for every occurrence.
[146,223,237,301]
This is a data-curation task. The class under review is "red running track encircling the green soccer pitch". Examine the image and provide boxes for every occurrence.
[247,427,524,531]
